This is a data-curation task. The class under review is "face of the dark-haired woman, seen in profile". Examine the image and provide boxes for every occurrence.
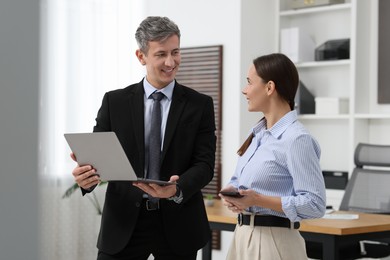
[242,64,269,112]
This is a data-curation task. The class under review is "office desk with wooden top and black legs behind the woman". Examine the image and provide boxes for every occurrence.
[202,200,390,260]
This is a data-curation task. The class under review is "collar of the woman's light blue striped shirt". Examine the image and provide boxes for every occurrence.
[252,110,298,138]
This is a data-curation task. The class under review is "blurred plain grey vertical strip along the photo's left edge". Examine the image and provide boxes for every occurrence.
[0,0,40,260]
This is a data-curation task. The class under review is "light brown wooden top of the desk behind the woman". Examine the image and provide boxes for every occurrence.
[206,200,390,235]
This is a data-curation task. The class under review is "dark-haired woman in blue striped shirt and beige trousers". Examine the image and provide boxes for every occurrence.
[220,53,326,260]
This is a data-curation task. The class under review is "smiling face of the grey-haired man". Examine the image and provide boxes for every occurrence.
[136,35,181,89]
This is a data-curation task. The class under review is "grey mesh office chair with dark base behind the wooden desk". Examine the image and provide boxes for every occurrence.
[307,143,390,260]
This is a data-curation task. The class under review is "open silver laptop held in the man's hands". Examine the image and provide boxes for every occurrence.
[64,132,176,185]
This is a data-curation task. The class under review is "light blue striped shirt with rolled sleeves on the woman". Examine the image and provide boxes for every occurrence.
[229,110,326,222]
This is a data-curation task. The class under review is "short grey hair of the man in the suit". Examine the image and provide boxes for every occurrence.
[135,16,180,54]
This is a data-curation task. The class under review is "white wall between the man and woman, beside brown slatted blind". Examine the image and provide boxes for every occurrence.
[143,0,276,260]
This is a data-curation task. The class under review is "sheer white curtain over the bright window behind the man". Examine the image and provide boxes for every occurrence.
[39,0,144,260]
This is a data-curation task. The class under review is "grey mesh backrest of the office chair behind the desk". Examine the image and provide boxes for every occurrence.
[340,143,390,214]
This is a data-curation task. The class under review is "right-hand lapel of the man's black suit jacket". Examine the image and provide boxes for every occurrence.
[161,83,187,161]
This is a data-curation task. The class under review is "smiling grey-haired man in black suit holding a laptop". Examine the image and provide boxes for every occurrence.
[71,17,216,260]
